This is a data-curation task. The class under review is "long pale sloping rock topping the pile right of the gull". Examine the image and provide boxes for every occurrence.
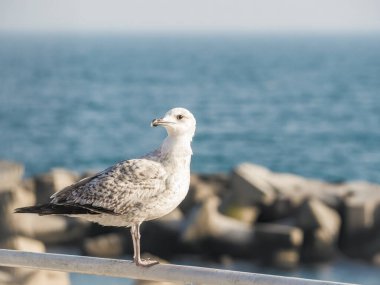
[231,163,360,211]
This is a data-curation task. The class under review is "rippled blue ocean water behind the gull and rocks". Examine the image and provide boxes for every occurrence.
[0,34,380,284]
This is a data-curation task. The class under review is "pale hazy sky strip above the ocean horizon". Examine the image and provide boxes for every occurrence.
[0,0,380,31]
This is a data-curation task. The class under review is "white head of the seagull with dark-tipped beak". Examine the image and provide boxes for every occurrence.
[151,108,196,140]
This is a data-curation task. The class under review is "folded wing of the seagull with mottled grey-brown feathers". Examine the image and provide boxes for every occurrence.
[51,158,167,215]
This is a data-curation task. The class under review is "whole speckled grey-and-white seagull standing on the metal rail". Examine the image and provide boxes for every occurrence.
[15,108,196,266]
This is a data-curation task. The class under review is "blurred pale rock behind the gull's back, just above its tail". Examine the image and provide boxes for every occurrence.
[35,168,79,204]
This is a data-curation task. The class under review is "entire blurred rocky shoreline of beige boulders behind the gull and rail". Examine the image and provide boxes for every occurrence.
[0,161,380,285]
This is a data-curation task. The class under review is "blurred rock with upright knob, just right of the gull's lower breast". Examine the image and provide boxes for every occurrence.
[181,197,253,257]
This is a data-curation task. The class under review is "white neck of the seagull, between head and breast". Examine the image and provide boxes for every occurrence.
[161,136,193,157]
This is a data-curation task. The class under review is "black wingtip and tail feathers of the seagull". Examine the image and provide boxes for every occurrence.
[15,203,98,216]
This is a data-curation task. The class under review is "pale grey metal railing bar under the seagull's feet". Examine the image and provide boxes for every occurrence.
[0,249,356,285]
